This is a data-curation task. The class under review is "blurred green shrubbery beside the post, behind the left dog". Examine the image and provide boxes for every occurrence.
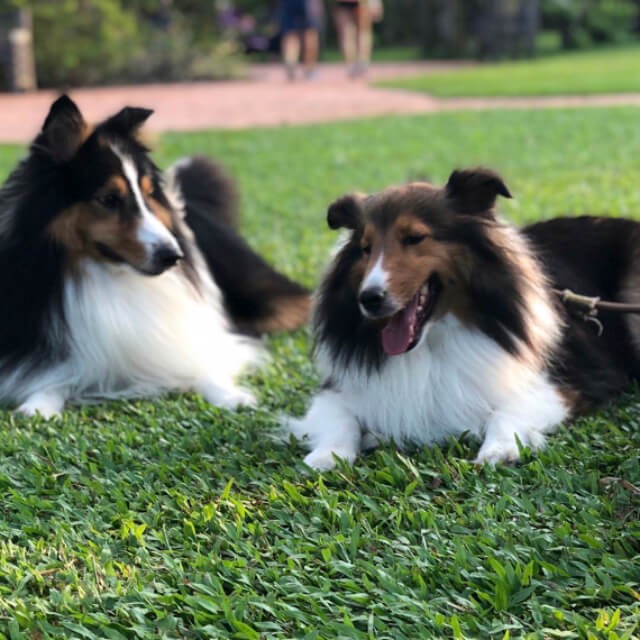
[5,0,241,88]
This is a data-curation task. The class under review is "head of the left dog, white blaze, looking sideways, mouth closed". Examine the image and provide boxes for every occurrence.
[36,96,183,275]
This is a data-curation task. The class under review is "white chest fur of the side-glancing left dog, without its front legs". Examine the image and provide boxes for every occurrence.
[65,262,249,396]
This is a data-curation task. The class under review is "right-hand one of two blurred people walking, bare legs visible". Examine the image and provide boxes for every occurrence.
[333,0,383,78]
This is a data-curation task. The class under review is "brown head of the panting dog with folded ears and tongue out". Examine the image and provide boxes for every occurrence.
[327,169,511,355]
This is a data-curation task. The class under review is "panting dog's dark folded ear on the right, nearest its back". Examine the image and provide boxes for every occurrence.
[445,168,511,215]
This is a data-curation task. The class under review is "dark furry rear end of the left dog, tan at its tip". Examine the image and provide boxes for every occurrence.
[170,156,311,334]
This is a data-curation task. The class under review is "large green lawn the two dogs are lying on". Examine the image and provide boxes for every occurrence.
[0,109,640,640]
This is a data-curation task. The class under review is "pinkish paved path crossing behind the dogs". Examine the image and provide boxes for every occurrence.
[0,62,640,142]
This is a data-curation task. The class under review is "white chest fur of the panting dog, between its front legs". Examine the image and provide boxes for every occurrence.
[330,316,523,443]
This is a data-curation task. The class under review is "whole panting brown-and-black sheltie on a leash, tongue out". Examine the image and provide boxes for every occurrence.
[290,169,640,468]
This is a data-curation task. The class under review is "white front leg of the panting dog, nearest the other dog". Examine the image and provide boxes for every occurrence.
[287,390,362,470]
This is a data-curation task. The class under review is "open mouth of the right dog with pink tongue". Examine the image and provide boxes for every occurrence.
[381,274,442,356]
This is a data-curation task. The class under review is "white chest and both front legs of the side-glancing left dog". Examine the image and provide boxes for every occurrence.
[10,260,260,415]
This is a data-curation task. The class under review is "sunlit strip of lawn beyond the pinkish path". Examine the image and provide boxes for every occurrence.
[381,45,640,98]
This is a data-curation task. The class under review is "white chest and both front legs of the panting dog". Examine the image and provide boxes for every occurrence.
[291,315,566,468]
